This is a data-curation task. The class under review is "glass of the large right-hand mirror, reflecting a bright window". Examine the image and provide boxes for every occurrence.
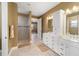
[67,14,79,35]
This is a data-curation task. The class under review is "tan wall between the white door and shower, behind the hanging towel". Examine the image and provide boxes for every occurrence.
[8,3,18,49]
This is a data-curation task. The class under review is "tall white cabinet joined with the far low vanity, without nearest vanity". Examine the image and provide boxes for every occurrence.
[43,10,65,55]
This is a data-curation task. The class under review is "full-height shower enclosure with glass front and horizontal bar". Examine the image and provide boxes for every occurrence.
[17,15,30,46]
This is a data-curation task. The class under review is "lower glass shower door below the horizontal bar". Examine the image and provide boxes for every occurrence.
[18,26,29,45]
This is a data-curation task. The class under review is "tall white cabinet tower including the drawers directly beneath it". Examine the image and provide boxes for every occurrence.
[52,10,65,55]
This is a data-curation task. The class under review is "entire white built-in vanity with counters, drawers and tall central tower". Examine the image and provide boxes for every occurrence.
[43,10,79,56]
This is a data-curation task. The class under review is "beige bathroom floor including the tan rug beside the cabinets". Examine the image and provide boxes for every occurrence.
[10,42,58,56]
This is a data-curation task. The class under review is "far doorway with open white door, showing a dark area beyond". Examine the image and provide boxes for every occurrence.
[31,18,42,43]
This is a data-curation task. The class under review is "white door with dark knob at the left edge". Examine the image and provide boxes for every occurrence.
[1,2,8,56]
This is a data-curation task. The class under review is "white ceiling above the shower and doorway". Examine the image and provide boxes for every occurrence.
[16,2,60,16]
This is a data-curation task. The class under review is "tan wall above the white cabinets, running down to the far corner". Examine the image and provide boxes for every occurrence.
[41,2,79,32]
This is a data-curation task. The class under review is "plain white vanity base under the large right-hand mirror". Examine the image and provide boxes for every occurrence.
[65,40,79,56]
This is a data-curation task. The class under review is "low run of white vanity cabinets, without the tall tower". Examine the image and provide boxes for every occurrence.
[44,36,79,56]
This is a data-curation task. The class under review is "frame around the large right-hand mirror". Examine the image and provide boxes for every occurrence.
[66,12,79,36]
